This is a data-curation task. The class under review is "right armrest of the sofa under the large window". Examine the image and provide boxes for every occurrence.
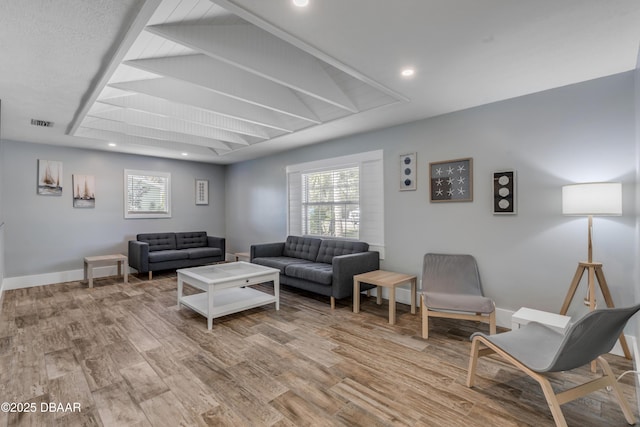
[332,251,380,299]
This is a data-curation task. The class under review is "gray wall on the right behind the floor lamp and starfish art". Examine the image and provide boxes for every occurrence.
[226,72,637,314]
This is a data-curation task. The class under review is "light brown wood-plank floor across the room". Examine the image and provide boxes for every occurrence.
[0,272,637,427]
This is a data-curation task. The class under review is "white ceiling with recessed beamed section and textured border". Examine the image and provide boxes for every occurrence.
[0,0,640,164]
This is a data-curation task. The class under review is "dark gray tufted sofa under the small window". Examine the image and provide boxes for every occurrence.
[129,231,225,280]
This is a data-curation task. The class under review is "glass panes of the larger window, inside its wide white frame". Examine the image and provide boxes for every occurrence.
[302,166,360,239]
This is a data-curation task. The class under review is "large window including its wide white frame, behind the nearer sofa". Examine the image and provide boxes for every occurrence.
[287,150,384,258]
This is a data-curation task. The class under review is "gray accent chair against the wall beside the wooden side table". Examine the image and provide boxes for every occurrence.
[420,253,496,339]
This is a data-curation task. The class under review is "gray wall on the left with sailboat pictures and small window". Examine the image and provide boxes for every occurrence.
[0,141,225,278]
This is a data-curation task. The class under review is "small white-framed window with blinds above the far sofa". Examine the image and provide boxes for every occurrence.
[124,169,171,218]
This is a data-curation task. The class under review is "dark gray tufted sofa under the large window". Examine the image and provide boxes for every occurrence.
[250,236,380,309]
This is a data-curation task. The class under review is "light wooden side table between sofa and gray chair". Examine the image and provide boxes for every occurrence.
[353,270,417,325]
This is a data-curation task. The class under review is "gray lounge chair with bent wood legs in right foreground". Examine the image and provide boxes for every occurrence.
[467,304,640,426]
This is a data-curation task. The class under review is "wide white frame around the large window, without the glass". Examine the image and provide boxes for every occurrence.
[286,150,385,259]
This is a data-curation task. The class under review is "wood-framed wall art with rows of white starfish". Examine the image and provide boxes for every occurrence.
[429,157,473,202]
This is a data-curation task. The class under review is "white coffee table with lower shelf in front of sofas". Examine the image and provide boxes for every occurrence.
[177,261,280,329]
